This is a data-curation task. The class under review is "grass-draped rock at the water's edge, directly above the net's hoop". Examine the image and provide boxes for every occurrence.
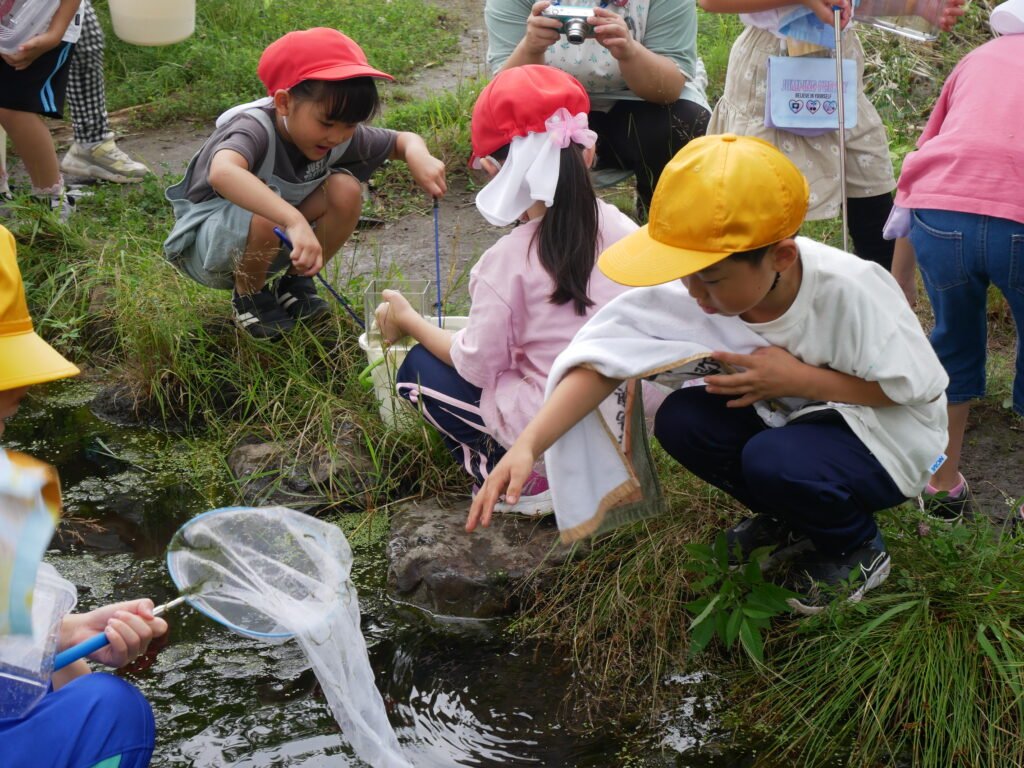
[227,430,375,512]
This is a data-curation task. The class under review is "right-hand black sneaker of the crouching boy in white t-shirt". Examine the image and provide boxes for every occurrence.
[785,531,892,616]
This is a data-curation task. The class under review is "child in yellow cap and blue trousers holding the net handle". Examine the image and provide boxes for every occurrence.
[0,226,167,768]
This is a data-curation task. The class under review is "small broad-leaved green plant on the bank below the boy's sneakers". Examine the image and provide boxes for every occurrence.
[685,534,798,664]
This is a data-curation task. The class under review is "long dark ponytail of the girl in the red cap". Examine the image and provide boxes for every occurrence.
[535,143,599,315]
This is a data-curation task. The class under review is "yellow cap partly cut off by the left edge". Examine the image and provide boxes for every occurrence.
[0,226,79,390]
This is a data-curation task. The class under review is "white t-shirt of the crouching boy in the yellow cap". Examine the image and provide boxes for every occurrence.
[746,238,949,497]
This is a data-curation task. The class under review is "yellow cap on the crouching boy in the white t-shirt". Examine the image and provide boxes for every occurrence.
[597,133,810,286]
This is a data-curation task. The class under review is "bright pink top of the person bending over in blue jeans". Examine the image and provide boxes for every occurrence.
[896,35,1024,222]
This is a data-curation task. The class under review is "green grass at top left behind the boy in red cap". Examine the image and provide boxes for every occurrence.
[95,0,459,124]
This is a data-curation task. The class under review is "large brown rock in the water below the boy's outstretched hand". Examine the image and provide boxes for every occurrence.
[387,499,579,618]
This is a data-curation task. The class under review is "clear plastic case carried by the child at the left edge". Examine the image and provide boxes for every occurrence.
[0,563,77,718]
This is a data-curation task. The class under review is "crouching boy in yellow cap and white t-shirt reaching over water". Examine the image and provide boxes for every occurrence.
[467,134,946,613]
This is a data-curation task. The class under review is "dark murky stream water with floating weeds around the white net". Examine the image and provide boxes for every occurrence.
[6,386,748,768]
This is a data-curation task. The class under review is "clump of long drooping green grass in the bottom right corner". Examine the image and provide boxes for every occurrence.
[736,510,1024,768]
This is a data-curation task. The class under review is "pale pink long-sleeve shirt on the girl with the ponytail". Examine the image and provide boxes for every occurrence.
[452,202,637,447]
